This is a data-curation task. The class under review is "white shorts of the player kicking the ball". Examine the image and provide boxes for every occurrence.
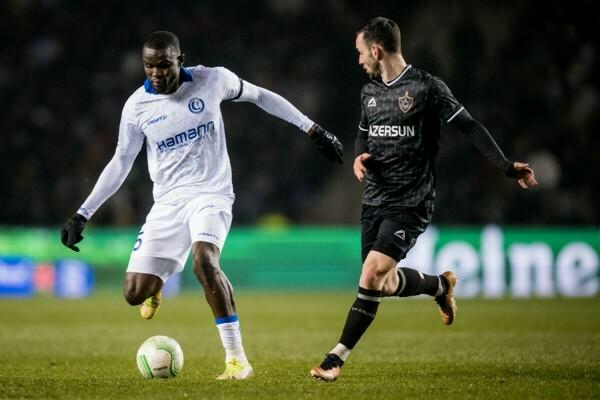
[127,195,233,281]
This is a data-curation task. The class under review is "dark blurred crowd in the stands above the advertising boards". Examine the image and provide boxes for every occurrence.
[0,0,600,226]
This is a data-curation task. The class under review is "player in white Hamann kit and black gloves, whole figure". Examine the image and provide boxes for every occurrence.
[61,31,343,379]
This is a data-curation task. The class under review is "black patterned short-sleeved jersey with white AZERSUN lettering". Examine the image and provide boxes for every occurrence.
[358,65,464,207]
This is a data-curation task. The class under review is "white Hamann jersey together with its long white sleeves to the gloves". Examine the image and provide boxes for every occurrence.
[77,65,314,219]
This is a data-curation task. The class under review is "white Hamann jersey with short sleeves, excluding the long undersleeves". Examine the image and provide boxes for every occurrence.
[117,66,243,203]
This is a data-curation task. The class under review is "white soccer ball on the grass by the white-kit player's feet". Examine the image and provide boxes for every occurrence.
[136,336,183,378]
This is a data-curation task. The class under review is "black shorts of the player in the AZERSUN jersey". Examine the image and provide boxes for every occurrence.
[360,204,433,262]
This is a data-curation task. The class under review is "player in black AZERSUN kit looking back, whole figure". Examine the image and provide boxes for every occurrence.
[310,17,537,382]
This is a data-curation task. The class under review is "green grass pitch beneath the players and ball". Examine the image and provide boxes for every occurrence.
[0,292,600,399]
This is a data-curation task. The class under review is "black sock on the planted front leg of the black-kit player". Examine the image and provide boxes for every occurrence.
[340,287,381,349]
